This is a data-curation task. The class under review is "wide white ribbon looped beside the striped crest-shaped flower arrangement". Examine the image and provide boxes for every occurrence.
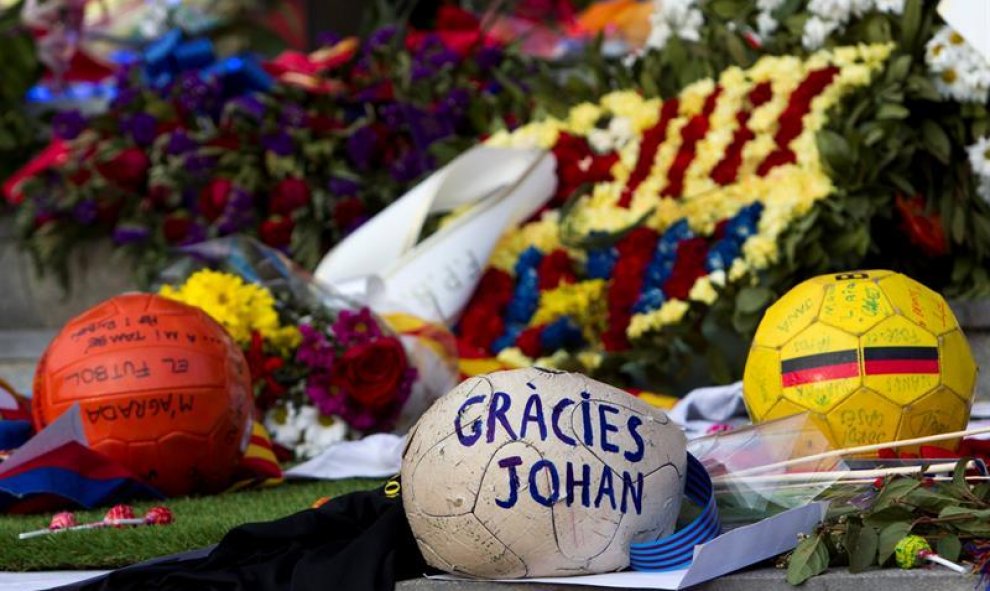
[315,146,556,324]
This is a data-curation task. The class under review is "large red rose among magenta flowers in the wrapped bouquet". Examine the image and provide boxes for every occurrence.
[333,337,409,411]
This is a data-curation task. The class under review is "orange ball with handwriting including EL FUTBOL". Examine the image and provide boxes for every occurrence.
[32,293,252,496]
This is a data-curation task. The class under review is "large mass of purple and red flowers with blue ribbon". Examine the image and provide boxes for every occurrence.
[8,9,548,290]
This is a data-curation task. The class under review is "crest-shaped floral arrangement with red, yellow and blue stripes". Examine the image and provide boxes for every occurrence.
[458,44,892,391]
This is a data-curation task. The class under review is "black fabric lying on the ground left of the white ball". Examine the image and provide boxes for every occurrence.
[61,490,430,591]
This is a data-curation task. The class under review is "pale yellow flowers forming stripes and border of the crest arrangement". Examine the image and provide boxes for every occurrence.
[478,45,892,361]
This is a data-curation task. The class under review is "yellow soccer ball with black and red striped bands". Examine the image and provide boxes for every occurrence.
[743,271,977,447]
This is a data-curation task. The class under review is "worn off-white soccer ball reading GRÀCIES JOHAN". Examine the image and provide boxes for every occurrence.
[402,368,687,578]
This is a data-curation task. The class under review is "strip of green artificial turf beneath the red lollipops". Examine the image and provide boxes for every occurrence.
[0,479,381,571]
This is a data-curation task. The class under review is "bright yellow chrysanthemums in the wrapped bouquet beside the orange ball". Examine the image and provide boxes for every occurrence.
[158,269,302,354]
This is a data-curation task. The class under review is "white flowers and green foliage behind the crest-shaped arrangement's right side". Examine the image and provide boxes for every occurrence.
[628,0,990,297]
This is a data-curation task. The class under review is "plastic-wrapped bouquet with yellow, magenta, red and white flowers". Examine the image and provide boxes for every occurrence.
[158,237,455,459]
